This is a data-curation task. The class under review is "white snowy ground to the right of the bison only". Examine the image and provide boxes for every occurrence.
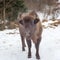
[40,26,60,60]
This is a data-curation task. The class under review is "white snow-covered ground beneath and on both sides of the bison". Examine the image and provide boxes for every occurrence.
[0,26,60,60]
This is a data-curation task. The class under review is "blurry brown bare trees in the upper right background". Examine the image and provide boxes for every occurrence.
[24,0,58,18]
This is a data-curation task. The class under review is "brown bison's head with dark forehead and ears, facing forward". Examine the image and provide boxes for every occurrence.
[19,12,39,37]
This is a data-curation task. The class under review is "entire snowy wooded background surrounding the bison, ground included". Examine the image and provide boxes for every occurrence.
[0,0,60,60]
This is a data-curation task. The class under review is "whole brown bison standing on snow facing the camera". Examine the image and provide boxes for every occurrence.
[18,11,42,59]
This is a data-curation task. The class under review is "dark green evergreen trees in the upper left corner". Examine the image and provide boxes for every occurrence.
[0,0,26,20]
